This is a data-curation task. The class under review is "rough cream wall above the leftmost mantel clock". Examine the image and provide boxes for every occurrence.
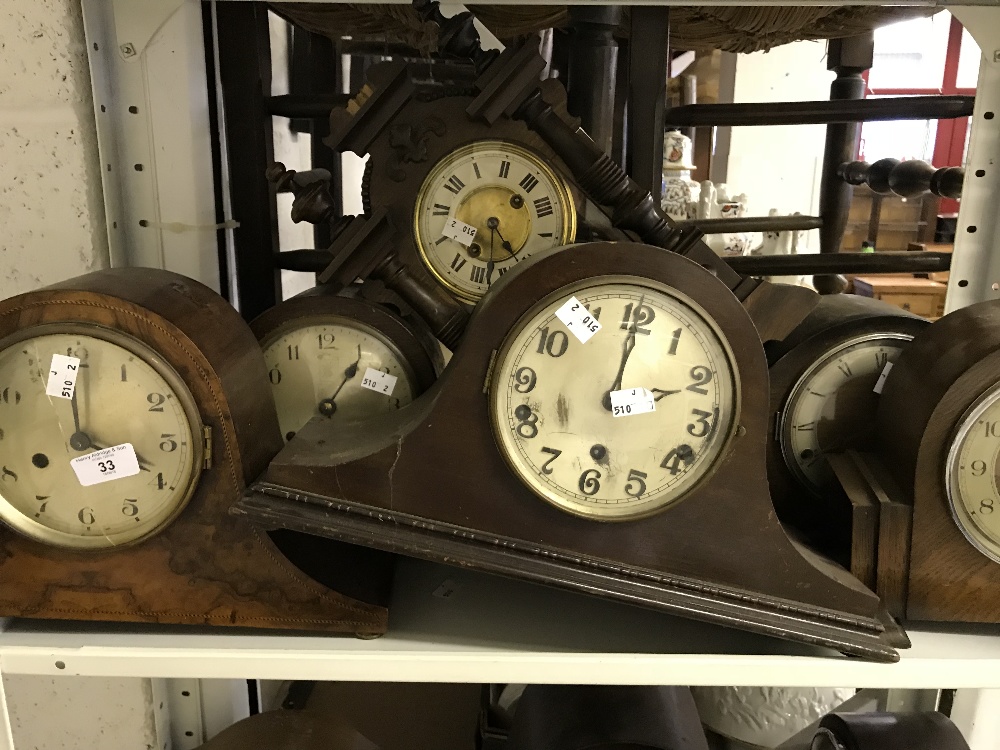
[0,0,108,297]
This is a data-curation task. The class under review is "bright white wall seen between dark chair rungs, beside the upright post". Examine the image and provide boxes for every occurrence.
[727,42,834,249]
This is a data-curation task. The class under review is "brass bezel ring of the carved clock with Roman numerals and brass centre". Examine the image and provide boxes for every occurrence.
[413,140,577,304]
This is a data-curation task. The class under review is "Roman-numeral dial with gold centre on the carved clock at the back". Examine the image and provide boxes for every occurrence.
[414,141,576,302]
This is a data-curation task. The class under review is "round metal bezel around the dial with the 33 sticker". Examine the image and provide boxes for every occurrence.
[0,322,205,552]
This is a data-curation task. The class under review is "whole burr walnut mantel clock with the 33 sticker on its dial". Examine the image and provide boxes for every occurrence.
[0,268,386,634]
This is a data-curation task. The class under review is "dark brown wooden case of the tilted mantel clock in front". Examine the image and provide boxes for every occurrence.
[240,243,898,661]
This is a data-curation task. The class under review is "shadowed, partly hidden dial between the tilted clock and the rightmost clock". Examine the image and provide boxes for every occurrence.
[778,333,913,492]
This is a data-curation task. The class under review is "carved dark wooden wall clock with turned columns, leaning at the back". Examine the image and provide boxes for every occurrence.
[320,57,818,348]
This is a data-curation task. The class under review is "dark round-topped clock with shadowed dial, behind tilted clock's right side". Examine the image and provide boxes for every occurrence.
[768,294,928,564]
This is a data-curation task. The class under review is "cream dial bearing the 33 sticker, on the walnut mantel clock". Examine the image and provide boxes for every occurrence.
[0,325,203,549]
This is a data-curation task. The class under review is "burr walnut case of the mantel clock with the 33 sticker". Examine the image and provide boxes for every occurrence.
[0,268,387,635]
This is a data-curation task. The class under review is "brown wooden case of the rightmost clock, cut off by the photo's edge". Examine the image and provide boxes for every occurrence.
[869,301,1000,623]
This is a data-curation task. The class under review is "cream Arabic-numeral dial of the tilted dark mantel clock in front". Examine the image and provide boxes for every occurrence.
[491,277,739,520]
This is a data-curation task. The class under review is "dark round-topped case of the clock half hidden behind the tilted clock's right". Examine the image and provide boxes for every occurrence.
[766,294,929,568]
